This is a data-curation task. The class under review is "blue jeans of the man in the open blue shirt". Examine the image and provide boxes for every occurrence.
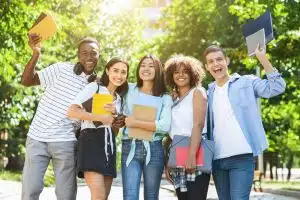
[213,154,255,200]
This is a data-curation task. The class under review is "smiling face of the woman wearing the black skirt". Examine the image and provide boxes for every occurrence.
[106,62,128,87]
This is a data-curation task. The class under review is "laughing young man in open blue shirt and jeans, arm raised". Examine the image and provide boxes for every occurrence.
[204,45,285,200]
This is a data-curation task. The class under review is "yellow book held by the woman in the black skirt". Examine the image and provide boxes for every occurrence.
[92,93,113,115]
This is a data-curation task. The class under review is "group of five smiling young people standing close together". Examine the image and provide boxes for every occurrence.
[22,34,285,200]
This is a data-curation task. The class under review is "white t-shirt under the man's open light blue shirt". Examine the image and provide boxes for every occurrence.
[213,82,252,160]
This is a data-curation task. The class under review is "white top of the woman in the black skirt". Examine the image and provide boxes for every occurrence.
[72,82,121,130]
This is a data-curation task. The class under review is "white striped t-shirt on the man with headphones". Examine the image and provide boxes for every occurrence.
[28,63,88,142]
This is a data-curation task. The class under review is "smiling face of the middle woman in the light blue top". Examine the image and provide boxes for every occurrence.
[139,58,155,81]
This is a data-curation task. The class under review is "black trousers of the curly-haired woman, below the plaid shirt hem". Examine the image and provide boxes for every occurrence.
[176,174,210,200]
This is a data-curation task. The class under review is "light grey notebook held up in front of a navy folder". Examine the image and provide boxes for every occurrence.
[246,29,266,56]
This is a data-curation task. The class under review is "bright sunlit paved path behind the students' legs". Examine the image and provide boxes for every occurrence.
[0,180,296,200]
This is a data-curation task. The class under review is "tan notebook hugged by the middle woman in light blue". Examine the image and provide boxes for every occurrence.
[128,104,157,141]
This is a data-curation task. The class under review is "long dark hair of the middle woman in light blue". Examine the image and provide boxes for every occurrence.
[136,55,166,96]
